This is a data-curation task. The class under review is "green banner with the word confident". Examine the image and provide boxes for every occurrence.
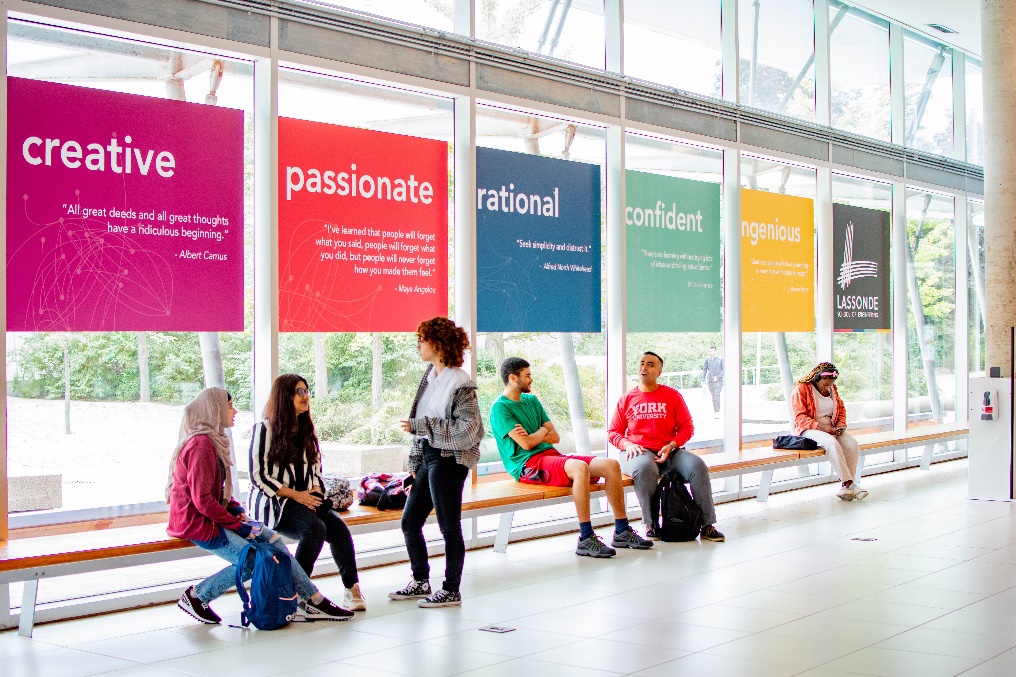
[625,172,722,331]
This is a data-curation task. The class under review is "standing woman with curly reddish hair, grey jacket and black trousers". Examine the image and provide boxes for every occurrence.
[388,317,484,608]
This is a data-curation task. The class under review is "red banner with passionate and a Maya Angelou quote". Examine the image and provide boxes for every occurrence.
[278,118,448,331]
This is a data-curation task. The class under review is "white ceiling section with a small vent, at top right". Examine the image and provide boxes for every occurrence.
[849,0,980,57]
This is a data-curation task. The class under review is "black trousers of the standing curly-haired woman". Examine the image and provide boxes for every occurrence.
[402,443,469,593]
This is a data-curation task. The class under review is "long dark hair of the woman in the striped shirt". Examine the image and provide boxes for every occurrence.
[264,374,321,466]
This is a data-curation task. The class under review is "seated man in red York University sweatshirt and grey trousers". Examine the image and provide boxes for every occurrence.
[608,353,724,542]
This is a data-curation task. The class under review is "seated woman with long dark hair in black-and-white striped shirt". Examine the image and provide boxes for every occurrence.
[248,374,367,611]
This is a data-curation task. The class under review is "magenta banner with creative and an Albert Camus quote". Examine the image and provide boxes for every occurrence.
[7,77,244,331]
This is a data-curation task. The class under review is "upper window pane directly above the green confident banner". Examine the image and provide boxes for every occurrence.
[625,0,722,99]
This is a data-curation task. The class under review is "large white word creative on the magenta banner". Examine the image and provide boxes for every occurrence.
[21,135,177,179]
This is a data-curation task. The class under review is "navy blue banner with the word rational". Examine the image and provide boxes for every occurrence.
[477,148,600,332]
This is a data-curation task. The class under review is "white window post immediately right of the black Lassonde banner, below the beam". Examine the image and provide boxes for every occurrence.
[890,181,907,431]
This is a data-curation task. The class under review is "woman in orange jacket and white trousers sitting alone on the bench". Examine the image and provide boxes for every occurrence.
[790,362,868,501]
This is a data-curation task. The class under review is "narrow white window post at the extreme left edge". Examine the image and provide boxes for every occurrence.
[0,0,10,536]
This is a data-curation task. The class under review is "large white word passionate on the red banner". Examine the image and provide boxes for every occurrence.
[285,165,434,204]
